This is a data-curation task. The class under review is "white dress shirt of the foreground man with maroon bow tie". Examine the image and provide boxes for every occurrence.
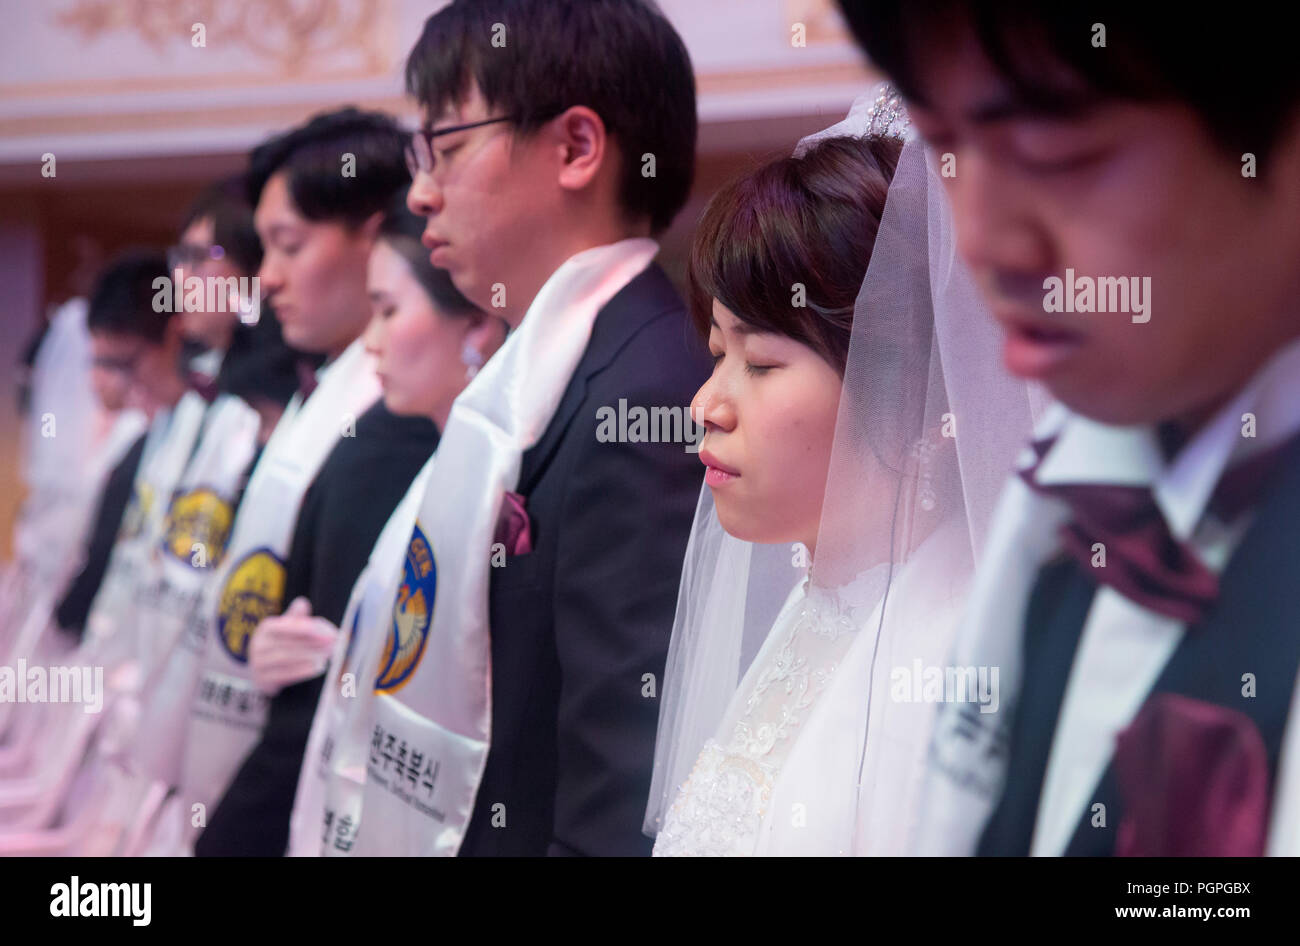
[1030,342,1300,855]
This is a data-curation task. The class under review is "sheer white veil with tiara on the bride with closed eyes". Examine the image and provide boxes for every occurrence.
[645,86,1041,852]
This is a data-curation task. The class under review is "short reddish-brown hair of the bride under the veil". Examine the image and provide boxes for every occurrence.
[686,135,902,376]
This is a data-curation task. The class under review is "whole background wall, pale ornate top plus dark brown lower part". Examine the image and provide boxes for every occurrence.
[0,0,868,557]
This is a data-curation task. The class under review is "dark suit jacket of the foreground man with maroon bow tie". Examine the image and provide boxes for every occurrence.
[976,438,1300,856]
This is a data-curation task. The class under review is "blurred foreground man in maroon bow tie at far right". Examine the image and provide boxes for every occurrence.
[840,0,1300,856]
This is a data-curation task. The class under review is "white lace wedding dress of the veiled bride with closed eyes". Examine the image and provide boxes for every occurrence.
[654,517,969,856]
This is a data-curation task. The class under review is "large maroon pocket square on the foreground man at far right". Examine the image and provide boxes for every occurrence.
[1114,693,1269,858]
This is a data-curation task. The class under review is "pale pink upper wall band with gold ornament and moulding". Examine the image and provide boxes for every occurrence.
[0,0,863,164]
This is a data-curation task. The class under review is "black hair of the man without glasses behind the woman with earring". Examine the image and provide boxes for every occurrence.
[248,107,411,226]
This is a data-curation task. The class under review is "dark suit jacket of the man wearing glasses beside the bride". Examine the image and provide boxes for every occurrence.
[460,264,710,855]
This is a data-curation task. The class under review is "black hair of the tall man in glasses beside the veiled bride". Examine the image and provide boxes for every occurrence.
[406,0,697,234]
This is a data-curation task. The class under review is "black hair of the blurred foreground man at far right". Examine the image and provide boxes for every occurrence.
[839,0,1300,162]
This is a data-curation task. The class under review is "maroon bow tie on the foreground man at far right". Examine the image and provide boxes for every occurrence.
[1021,426,1291,624]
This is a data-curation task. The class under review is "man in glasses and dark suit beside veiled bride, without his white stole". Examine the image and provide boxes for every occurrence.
[407,0,709,855]
